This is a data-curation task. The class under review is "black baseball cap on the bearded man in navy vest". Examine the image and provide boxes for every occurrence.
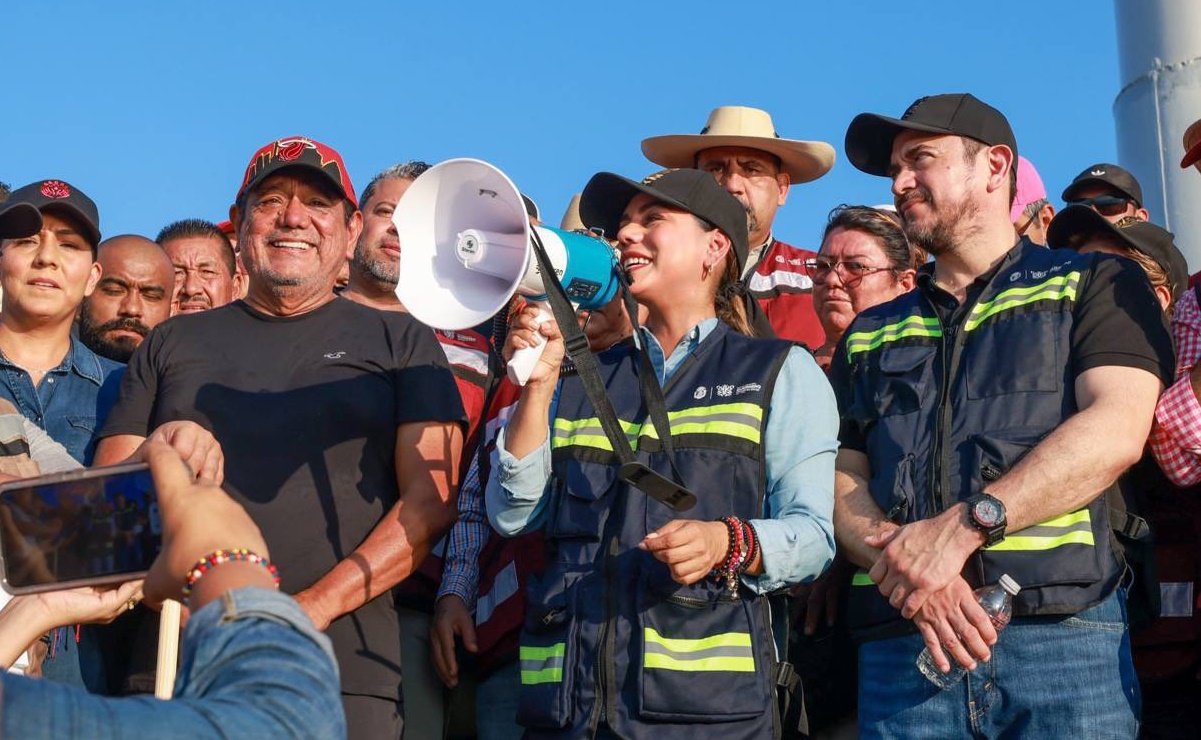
[846,93,1017,177]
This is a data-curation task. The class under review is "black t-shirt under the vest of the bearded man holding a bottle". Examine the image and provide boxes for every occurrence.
[829,246,1176,452]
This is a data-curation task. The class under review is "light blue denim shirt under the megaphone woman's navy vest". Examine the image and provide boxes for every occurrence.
[485,318,838,592]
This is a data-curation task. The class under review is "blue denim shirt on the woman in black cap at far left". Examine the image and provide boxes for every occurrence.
[0,336,125,465]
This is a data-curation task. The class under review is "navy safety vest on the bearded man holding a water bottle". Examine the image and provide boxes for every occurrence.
[835,240,1123,638]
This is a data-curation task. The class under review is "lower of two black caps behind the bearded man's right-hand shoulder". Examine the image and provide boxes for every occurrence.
[1047,205,1189,303]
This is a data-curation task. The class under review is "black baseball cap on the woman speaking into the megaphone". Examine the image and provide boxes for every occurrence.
[580,169,748,273]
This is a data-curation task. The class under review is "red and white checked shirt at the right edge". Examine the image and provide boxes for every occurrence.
[1149,290,1201,485]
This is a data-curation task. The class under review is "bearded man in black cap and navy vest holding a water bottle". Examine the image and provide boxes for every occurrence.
[830,94,1172,738]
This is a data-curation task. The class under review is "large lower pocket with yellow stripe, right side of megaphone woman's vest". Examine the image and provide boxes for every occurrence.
[635,590,772,723]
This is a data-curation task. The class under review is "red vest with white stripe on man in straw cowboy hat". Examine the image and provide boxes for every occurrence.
[746,239,825,350]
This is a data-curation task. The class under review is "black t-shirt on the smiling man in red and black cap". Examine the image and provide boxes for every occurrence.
[101,299,464,698]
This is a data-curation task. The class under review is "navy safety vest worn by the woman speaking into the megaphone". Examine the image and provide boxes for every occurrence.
[518,323,790,740]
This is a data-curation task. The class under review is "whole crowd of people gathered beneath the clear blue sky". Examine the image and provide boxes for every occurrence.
[0,94,1201,740]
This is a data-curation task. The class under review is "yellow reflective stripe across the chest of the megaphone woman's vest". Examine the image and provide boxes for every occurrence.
[551,404,763,450]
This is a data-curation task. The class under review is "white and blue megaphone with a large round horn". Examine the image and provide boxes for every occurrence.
[392,159,619,386]
